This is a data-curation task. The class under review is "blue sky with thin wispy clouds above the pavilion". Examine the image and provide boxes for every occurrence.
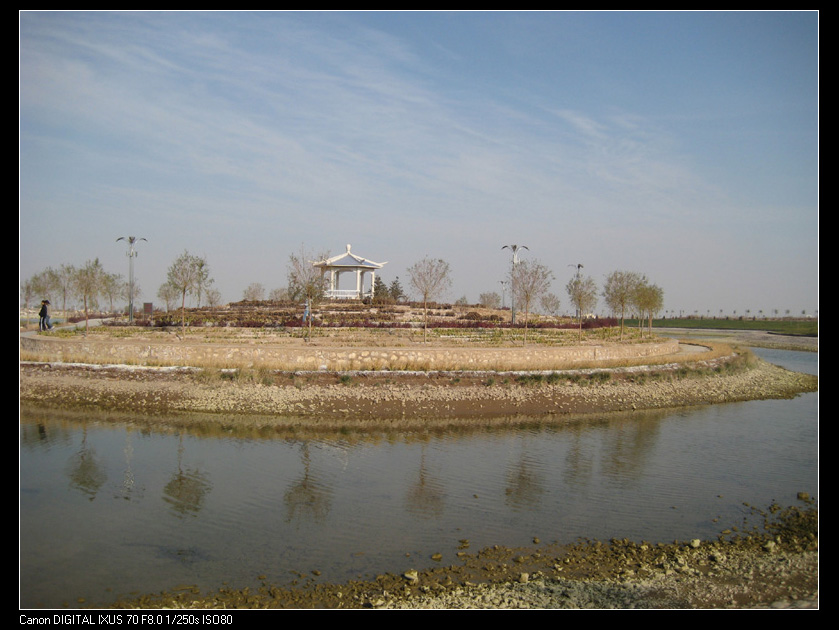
[19,11,819,315]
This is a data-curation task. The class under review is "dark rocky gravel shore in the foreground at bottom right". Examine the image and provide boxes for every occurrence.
[106,496,818,610]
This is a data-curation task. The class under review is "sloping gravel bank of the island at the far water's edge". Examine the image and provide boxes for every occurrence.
[20,348,818,428]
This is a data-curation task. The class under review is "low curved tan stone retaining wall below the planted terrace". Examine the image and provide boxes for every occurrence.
[20,335,679,371]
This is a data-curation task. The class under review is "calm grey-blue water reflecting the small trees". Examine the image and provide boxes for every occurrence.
[20,351,818,608]
